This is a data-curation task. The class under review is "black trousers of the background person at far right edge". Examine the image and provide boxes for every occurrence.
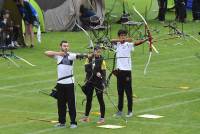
[192,0,200,20]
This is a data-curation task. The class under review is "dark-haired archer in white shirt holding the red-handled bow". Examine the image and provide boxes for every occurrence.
[112,29,147,117]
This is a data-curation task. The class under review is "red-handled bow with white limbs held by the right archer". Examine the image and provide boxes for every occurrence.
[133,5,159,75]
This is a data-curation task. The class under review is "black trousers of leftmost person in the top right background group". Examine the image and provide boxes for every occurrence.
[158,0,167,21]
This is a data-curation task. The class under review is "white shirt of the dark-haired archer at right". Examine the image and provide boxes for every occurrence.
[116,42,134,71]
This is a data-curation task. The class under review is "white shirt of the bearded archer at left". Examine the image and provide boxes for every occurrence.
[54,53,76,84]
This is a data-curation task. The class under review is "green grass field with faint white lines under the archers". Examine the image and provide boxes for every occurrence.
[0,13,200,134]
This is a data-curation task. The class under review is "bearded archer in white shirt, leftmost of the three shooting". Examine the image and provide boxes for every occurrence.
[45,41,87,128]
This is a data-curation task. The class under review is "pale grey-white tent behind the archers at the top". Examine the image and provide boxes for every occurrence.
[36,0,105,31]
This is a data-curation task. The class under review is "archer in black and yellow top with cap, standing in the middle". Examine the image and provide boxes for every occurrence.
[80,46,106,124]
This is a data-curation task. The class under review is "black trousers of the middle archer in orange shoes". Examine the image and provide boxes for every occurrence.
[85,82,105,118]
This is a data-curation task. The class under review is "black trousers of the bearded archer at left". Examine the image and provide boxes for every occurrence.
[56,83,77,124]
